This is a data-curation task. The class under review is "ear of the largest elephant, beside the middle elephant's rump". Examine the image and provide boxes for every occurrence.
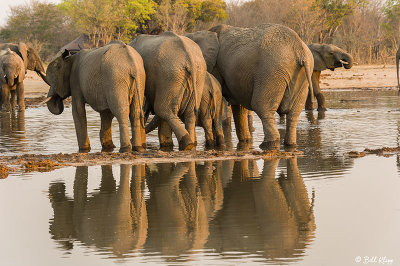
[185,31,219,73]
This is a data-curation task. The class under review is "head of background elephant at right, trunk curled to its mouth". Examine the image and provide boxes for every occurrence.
[308,43,354,71]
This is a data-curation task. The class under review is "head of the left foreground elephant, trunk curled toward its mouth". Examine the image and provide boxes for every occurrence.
[44,50,72,115]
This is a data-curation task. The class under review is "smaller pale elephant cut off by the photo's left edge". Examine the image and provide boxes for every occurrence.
[0,49,25,111]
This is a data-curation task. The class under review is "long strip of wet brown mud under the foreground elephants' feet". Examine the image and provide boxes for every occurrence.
[0,150,303,177]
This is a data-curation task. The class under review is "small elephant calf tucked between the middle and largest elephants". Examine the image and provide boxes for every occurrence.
[146,72,225,148]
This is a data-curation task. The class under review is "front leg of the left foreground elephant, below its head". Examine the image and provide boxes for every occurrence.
[72,98,90,152]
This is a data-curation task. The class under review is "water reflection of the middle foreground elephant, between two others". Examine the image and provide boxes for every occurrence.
[145,162,212,260]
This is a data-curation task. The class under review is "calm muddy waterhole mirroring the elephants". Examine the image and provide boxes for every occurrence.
[0,91,400,266]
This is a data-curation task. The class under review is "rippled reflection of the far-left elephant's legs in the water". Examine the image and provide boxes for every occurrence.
[0,112,26,152]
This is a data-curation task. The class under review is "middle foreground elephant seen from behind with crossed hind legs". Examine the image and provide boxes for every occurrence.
[129,32,207,150]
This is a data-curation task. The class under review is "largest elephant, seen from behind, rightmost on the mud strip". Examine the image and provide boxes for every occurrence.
[186,24,314,150]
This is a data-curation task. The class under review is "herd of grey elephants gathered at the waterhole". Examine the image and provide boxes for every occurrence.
[0,24,353,152]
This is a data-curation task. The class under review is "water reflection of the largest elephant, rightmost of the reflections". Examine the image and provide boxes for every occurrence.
[206,158,315,260]
